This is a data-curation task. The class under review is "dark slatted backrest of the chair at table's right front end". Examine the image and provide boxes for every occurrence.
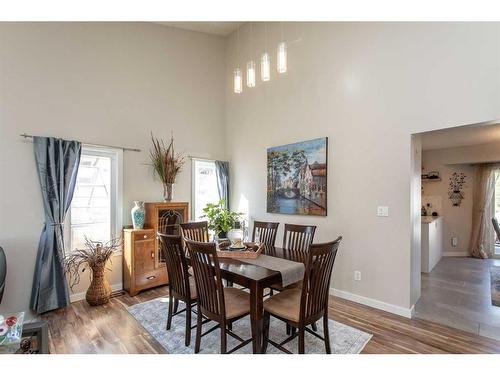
[300,237,342,322]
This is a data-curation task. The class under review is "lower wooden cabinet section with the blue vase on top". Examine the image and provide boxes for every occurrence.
[123,229,168,296]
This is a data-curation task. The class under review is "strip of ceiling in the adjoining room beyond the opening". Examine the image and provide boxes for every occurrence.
[421,121,500,150]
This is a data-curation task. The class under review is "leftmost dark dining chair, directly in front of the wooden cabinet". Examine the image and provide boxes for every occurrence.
[157,232,204,346]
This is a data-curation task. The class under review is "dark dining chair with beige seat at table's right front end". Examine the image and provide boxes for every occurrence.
[263,237,342,354]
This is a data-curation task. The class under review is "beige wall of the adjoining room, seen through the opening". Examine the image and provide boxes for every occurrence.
[422,143,500,256]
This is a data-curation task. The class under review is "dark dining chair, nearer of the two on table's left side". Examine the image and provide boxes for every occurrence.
[185,239,252,354]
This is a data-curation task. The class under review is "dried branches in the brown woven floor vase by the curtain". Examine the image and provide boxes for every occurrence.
[64,237,122,290]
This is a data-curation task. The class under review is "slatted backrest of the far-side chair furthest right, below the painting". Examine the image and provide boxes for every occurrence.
[283,224,316,263]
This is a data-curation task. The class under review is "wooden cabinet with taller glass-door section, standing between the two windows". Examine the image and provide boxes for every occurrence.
[123,202,189,296]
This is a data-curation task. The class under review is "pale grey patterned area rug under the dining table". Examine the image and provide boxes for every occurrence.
[127,297,372,354]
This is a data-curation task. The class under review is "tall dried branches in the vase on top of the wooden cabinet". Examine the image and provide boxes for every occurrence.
[149,133,185,184]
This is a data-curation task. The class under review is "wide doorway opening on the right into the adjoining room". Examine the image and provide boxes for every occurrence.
[411,121,500,340]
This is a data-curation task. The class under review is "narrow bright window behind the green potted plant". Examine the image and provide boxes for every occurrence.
[192,159,220,220]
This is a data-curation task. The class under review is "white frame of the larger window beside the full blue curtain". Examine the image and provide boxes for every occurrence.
[64,144,123,255]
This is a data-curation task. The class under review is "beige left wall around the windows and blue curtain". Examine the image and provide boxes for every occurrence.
[0,23,225,313]
